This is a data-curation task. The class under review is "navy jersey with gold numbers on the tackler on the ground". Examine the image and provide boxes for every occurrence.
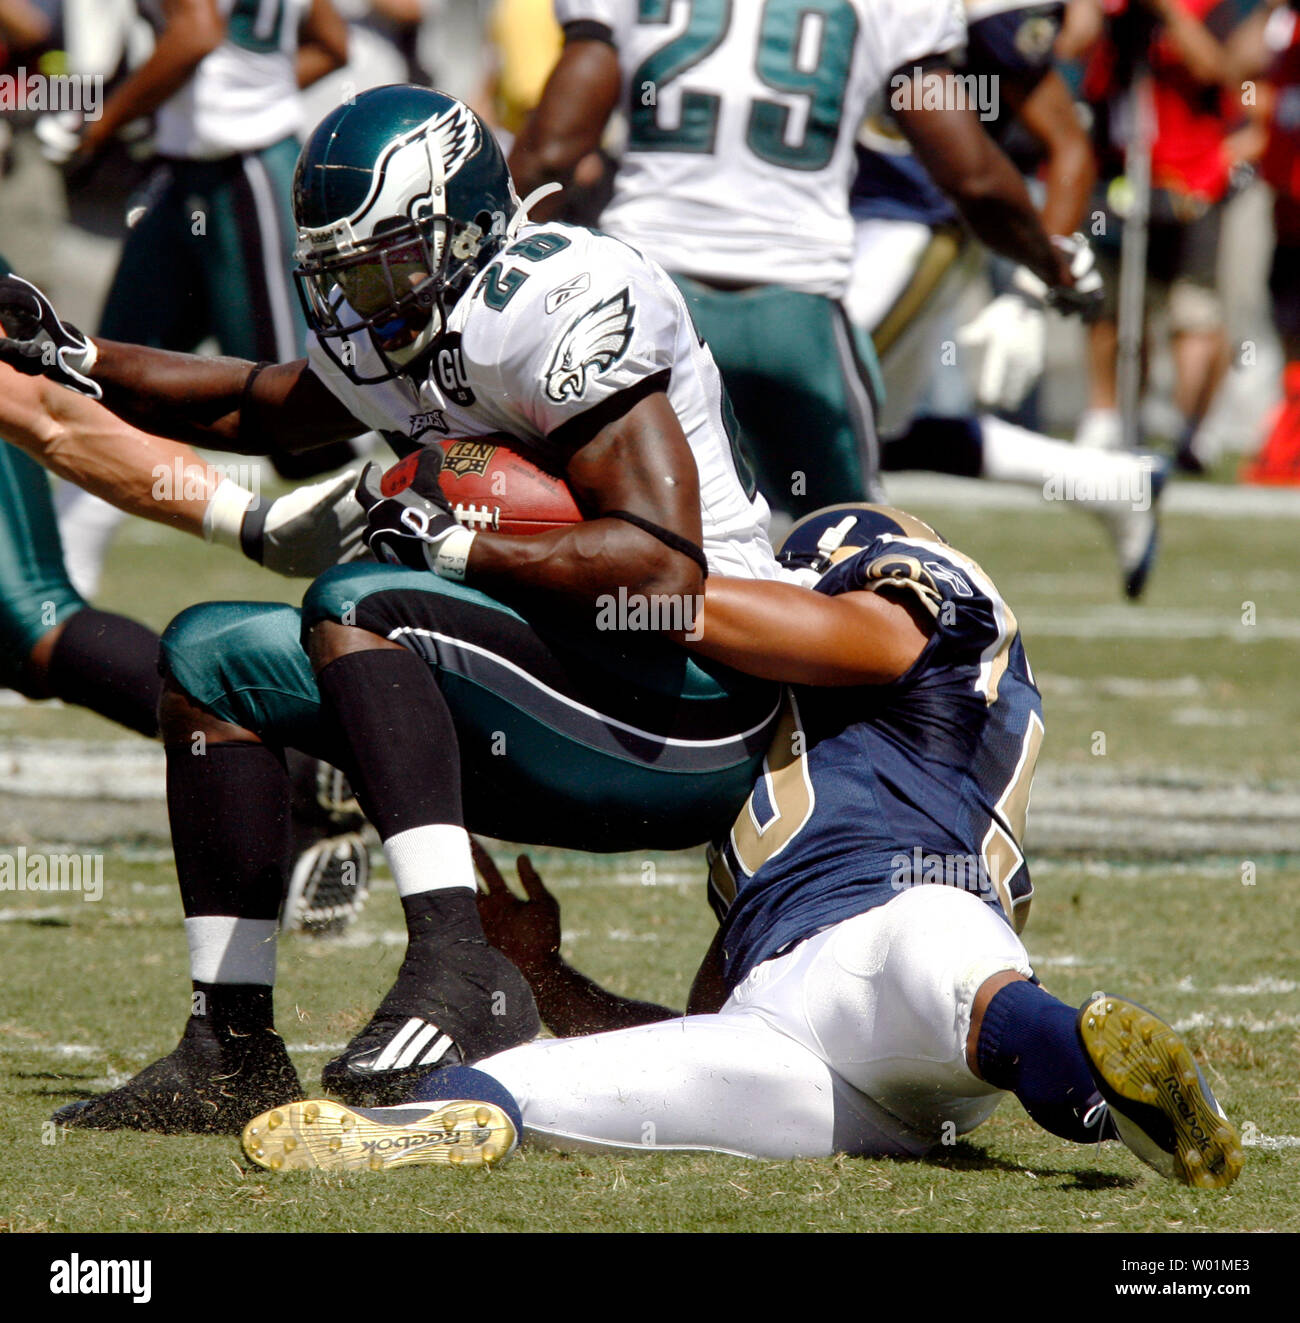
[709,525,1043,986]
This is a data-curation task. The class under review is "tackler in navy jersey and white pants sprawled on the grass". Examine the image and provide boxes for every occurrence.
[243,505,1242,1187]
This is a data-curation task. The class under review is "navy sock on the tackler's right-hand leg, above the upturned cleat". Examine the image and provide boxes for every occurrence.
[976,982,1111,1144]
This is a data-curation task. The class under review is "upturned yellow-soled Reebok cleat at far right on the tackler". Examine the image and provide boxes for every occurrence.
[1078,996,1244,1189]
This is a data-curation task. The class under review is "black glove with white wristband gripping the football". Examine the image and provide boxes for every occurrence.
[357,446,475,579]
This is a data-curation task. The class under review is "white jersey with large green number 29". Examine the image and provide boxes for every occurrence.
[555,0,965,298]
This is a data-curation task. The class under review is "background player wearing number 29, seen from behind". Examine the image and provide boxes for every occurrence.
[510,0,1100,512]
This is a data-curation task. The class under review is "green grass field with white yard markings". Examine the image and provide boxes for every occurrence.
[0,484,1300,1232]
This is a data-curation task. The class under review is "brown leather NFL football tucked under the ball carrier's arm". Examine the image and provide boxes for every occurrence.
[438,437,582,533]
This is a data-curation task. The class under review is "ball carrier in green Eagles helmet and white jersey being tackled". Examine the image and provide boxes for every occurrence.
[15,87,825,1130]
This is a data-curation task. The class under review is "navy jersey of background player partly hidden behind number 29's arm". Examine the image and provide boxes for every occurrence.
[849,0,1065,226]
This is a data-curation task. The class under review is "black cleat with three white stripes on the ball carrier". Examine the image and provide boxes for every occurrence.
[320,938,541,1107]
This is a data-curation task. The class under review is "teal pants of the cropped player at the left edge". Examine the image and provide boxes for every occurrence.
[0,442,86,692]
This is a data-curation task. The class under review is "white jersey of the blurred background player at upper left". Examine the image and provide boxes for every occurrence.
[140,0,308,160]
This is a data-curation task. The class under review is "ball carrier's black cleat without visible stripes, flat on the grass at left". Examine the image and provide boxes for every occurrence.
[53,1016,303,1135]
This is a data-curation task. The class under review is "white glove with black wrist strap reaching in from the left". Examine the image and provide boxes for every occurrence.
[239,468,365,578]
